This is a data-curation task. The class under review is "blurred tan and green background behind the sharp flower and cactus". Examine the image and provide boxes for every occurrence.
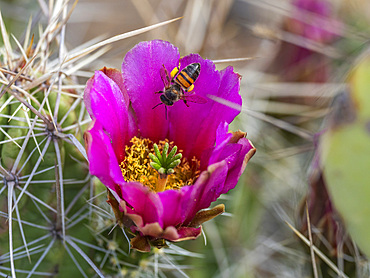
[0,0,370,277]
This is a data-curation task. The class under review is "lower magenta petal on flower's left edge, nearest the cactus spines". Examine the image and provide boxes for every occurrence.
[84,121,125,190]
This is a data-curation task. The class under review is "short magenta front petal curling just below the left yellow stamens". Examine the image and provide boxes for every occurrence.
[121,182,163,227]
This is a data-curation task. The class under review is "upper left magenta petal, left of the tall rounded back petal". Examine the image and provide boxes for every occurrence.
[84,71,134,162]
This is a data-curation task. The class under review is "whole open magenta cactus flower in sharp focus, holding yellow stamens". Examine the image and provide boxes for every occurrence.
[84,40,255,251]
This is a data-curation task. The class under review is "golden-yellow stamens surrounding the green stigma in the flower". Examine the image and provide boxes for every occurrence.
[120,137,200,191]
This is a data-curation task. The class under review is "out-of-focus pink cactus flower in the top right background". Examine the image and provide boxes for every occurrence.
[275,0,341,83]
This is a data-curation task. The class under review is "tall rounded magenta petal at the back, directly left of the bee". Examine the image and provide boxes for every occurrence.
[122,40,180,142]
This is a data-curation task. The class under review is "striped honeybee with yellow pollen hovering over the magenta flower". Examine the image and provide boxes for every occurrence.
[152,63,207,119]
